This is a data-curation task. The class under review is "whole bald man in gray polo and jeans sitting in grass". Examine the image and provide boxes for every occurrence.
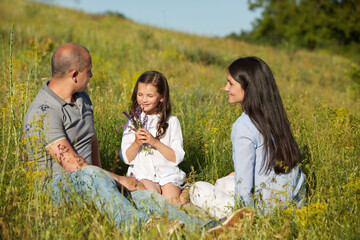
[24,43,248,230]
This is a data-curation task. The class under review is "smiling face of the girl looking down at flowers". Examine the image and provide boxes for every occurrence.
[136,83,164,115]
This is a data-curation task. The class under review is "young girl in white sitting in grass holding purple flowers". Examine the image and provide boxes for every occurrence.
[120,71,188,204]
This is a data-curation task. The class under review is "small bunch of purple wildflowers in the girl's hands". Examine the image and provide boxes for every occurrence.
[116,105,151,152]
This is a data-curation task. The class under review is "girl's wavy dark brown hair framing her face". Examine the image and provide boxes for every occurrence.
[131,71,171,139]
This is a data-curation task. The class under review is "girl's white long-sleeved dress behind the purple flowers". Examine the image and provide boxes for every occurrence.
[119,113,186,186]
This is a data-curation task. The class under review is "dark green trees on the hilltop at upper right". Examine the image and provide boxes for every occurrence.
[239,0,360,49]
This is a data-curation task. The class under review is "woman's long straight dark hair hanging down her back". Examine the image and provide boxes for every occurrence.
[228,57,301,174]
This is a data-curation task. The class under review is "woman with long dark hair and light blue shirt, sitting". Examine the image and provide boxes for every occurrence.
[190,57,305,216]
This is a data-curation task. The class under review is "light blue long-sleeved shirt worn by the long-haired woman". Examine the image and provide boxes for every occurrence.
[231,112,306,212]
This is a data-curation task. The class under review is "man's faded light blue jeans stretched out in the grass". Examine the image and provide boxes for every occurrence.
[51,165,216,231]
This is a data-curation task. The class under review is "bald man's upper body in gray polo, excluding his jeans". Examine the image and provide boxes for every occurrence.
[24,43,143,191]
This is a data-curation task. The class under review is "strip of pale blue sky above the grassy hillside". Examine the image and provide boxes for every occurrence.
[34,0,261,37]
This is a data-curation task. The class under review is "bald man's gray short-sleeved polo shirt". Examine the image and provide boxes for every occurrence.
[24,80,95,178]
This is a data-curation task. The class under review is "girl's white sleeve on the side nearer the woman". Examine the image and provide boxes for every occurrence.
[168,116,185,165]
